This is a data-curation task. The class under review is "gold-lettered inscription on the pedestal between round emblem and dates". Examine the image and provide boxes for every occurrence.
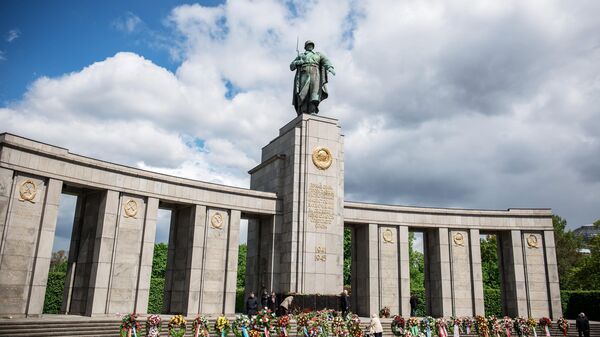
[307,184,335,229]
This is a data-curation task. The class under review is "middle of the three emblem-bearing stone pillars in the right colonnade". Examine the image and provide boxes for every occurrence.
[449,230,481,317]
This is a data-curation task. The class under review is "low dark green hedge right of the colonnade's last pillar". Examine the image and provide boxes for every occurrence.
[560,290,600,321]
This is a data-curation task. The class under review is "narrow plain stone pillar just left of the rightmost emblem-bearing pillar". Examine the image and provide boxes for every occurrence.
[499,230,528,317]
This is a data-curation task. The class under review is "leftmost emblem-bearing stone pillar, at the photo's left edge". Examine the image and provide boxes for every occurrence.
[0,169,62,316]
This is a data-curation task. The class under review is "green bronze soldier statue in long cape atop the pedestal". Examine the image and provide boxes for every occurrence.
[290,40,335,115]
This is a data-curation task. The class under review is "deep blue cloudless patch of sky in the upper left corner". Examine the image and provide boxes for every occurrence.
[0,0,222,102]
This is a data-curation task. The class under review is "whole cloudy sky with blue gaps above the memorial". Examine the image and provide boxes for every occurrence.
[0,0,600,251]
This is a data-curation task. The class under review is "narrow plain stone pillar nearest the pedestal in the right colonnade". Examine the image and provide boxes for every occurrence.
[352,224,380,316]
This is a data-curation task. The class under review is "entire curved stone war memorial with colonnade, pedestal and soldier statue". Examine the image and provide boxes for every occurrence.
[0,42,562,319]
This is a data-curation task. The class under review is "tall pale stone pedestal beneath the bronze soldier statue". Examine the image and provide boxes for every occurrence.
[247,114,344,295]
